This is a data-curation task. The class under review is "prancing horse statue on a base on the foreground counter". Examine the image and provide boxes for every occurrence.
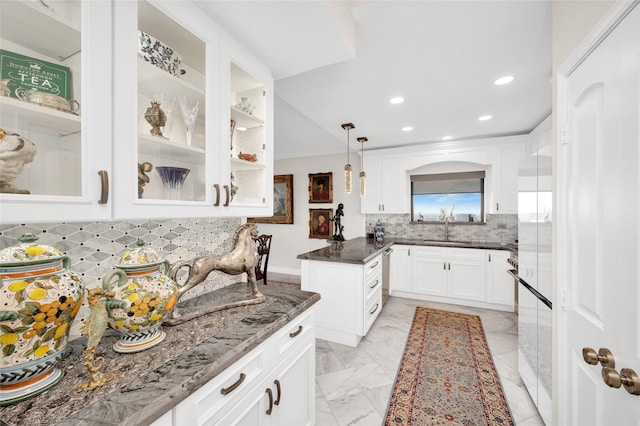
[167,223,266,324]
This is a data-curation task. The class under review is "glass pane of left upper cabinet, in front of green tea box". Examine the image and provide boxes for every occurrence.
[0,0,83,199]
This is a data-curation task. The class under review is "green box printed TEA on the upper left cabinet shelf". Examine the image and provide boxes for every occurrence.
[0,49,71,100]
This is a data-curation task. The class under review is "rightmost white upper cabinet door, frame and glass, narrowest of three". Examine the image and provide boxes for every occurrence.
[218,41,275,216]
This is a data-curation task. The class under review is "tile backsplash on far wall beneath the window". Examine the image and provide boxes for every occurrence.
[365,214,518,244]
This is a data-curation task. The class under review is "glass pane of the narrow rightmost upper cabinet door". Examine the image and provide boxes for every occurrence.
[230,63,266,205]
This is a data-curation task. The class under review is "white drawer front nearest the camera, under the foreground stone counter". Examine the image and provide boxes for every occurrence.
[174,340,266,425]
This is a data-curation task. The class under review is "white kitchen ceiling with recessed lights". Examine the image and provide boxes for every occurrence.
[197,0,551,159]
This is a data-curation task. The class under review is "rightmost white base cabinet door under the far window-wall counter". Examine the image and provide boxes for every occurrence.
[485,250,514,311]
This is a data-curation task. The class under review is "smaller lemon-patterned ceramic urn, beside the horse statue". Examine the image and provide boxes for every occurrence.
[102,240,178,353]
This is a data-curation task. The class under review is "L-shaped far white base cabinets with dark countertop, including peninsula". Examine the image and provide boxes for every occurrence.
[297,237,516,347]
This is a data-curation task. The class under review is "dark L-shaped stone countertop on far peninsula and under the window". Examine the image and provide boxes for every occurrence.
[297,237,517,264]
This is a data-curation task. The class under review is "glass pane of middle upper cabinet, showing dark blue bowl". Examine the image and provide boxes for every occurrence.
[138,1,207,201]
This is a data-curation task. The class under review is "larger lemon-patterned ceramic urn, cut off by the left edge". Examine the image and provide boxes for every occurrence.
[0,234,84,406]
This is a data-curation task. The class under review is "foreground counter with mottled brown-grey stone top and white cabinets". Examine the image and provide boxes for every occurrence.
[0,283,320,426]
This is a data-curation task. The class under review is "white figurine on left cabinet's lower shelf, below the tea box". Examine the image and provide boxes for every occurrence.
[0,128,37,194]
